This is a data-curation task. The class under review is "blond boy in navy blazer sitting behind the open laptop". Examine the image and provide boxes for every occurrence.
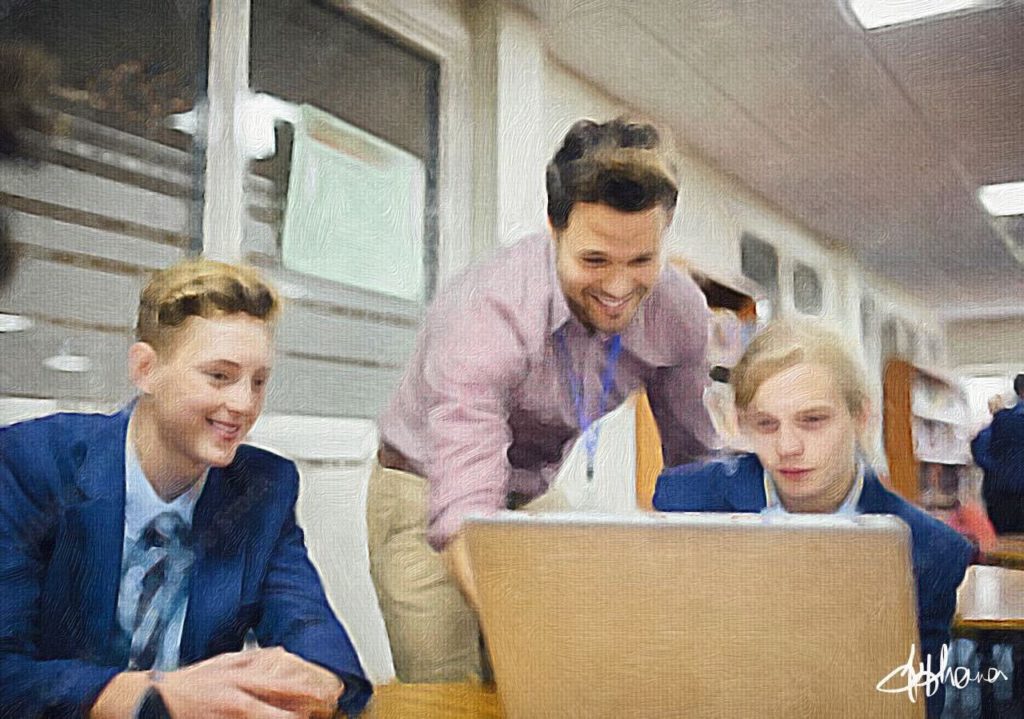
[653,321,974,716]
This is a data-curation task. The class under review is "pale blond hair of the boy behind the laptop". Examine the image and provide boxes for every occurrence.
[729,320,868,417]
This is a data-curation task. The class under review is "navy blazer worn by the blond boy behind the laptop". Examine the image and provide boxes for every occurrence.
[653,455,974,716]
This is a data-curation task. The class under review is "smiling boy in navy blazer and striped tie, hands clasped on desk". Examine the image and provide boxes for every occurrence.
[0,260,371,719]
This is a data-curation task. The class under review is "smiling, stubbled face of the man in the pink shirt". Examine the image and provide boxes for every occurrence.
[555,203,669,333]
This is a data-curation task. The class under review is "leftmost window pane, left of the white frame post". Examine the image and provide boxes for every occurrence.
[0,0,209,410]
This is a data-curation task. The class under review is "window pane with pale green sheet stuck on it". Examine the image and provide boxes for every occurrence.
[241,0,440,418]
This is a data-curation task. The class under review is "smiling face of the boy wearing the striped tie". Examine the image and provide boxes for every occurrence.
[132,313,273,467]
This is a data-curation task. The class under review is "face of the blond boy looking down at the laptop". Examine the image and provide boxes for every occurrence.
[742,363,867,512]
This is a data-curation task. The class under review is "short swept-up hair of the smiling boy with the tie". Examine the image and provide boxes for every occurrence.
[135,259,281,352]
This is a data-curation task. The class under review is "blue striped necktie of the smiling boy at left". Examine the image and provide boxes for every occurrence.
[128,512,193,670]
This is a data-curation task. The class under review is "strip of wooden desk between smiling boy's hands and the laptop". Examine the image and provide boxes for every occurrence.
[361,683,504,719]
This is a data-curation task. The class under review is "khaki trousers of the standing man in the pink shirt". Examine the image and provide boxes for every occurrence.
[367,462,481,682]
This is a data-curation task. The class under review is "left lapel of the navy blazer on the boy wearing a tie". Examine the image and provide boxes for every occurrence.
[64,408,131,663]
